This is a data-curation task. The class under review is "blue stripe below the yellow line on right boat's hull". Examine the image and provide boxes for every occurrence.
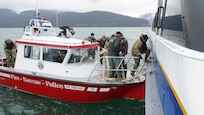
[153,51,183,115]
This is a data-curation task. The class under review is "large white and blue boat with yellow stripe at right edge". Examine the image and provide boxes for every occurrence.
[149,0,204,115]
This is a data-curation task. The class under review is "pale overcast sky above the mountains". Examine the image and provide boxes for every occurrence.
[0,0,157,17]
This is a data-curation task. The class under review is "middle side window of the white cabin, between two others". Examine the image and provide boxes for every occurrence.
[43,48,67,63]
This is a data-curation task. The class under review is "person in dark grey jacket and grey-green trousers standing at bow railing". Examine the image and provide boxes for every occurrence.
[109,31,123,81]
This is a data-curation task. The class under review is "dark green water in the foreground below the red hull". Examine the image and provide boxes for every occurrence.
[0,87,145,115]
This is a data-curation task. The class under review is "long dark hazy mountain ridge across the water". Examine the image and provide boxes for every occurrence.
[0,9,149,28]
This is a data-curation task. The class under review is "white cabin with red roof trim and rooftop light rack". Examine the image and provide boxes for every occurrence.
[14,17,102,79]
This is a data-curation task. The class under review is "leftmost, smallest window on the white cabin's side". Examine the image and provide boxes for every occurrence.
[24,46,40,60]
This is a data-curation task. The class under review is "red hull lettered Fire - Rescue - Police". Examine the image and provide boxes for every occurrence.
[0,69,145,103]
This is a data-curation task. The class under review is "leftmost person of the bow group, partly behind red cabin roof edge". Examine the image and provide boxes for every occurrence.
[85,33,96,59]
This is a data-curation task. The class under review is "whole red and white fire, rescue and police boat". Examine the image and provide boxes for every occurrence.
[0,10,145,103]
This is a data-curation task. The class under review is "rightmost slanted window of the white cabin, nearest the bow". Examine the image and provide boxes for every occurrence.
[68,48,92,63]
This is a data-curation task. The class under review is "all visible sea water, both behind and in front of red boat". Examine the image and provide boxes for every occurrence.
[0,27,149,115]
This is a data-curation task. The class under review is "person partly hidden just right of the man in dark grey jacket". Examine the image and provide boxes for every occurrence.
[120,34,128,78]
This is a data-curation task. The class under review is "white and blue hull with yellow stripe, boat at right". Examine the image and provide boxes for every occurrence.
[151,32,204,115]
